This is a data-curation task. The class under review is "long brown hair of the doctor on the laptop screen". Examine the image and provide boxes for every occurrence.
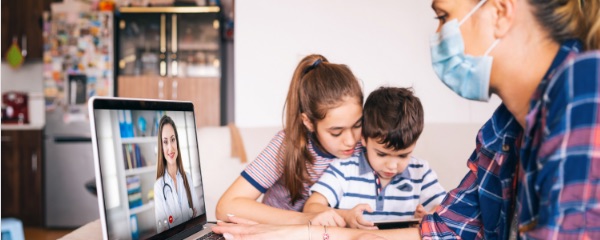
[156,115,195,208]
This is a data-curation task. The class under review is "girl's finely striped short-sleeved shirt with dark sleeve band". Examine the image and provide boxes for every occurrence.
[241,131,362,211]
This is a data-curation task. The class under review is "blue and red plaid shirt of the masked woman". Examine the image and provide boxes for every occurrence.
[421,41,600,239]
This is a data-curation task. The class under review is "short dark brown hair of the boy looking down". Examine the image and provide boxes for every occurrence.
[362,87,423,151]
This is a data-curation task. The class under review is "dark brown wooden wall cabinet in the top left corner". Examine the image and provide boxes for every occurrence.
[2,0,56,61]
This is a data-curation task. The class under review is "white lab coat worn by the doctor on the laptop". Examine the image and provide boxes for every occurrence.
[154,169,202,233]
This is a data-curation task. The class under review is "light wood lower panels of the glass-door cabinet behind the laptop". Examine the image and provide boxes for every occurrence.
[117,76,221,127]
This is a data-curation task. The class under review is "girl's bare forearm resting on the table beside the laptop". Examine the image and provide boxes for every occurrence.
[216,176,316,224]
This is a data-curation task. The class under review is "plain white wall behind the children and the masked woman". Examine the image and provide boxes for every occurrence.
[235,0,500,127]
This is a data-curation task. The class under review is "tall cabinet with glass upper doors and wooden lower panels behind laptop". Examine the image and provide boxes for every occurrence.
[115,6,226,127]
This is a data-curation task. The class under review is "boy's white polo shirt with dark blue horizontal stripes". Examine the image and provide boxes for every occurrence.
[310,153,446,221]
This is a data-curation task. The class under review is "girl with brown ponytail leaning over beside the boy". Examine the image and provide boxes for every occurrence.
[216,55,363,224]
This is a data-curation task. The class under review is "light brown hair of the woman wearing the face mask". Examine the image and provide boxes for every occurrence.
[528,0,600,50]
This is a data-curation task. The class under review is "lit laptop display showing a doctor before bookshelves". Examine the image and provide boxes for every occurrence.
[95,110,205,239]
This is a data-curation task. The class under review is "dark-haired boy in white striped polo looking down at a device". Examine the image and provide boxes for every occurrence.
[304,87,446,228]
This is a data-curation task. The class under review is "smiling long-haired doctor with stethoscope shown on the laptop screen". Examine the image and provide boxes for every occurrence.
[154,115,199,233]
